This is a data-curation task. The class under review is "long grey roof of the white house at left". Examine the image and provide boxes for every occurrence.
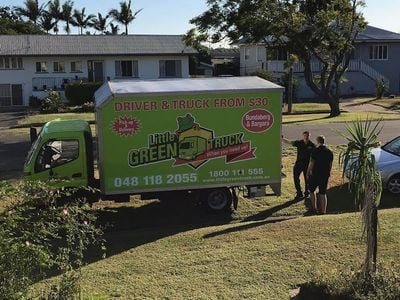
[0,35,197,56]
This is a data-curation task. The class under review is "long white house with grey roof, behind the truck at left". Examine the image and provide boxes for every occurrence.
[0,35,196,108]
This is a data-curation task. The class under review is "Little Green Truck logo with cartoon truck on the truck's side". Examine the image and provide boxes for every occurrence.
[128,114,256,169]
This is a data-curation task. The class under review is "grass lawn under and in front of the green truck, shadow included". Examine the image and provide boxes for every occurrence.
[24,147,400,299]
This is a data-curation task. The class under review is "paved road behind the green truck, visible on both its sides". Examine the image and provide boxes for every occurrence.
[0,113,400,180]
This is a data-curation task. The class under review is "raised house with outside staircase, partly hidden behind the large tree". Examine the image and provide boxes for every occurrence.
[239,26,400,98]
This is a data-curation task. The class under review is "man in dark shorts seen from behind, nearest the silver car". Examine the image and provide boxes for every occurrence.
[307,135,333,214]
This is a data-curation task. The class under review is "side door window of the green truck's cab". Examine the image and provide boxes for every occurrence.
[35,140,79,172]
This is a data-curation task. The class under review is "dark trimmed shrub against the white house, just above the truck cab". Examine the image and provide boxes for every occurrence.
[65,82,102,105]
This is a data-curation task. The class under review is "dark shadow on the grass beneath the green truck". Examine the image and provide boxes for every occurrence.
[88,198,233,262]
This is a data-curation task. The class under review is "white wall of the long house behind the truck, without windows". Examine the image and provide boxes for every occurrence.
[0,55,189,105]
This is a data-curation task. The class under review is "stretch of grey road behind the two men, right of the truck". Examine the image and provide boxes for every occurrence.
[282,120,400,145]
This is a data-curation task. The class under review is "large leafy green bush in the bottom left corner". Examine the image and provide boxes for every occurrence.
[0,182,103,300]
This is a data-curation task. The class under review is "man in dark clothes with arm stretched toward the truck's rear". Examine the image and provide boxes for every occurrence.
[283,131,315,199]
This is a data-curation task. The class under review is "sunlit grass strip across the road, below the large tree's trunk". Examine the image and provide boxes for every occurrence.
[282,112,400,124]
